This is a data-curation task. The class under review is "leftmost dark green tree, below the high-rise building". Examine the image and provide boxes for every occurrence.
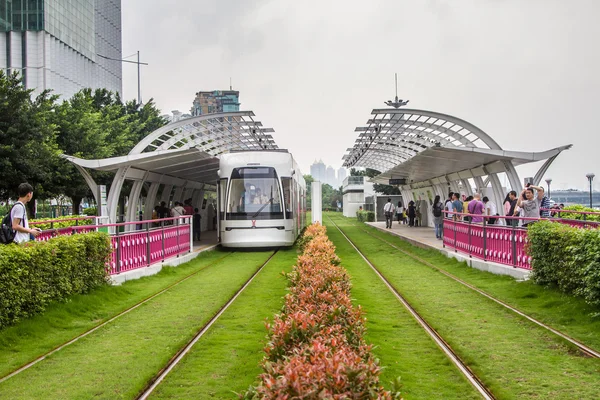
[0,71,59,212]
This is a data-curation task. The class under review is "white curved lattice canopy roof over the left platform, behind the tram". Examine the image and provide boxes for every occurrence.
[64,111,277,187]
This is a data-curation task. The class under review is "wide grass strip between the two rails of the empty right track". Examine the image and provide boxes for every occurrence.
[328,217,600,399]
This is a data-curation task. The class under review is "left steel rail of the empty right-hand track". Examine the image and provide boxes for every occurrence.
[327,216,496,400]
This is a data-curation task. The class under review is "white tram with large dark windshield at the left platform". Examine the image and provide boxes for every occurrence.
[217,150,306,247]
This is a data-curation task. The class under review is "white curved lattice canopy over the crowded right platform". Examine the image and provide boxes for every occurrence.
[343,109,571,189]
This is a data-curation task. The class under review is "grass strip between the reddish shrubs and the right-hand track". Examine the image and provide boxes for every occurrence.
[325,218,479,399]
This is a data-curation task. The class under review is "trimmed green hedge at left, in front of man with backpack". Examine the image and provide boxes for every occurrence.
[0,232,111,329]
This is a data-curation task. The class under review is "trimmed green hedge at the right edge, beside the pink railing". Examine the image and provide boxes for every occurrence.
[527,221,600,305]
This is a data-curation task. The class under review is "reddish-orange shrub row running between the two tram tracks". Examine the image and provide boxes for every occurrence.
[243,224,400,399]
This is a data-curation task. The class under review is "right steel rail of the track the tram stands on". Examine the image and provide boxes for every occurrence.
[135,250,278,400]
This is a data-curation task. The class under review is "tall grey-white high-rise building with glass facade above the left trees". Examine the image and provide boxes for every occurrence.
[0,0,123,99]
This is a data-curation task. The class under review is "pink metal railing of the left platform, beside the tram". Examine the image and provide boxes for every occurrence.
[36,216,192,275]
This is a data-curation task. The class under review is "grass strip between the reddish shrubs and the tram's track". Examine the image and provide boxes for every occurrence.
[151,248,297,399]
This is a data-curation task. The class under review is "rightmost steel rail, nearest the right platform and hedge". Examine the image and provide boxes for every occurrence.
[328,217,600,358]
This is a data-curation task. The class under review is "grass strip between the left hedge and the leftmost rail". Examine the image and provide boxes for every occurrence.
[0,251,228,377]
